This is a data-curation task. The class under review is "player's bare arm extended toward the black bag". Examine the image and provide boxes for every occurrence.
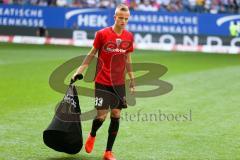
[72,47,98,79]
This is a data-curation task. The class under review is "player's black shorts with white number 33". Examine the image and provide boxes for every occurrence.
[95,83,127,110]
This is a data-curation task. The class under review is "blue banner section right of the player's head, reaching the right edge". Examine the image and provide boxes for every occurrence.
[128,11,240,36]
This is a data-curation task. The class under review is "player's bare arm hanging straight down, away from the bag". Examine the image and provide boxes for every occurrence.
[126,53,135,94]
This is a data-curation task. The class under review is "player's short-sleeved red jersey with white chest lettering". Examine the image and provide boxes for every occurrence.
[93,27,133,86]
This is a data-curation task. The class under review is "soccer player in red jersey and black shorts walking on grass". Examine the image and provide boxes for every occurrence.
[72,4,135,160]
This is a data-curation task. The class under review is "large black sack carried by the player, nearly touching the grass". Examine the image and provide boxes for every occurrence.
[43,74,83,154]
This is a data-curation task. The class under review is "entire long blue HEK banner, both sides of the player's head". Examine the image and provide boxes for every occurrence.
[0,5,240,36]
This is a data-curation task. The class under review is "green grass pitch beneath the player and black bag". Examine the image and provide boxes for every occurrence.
[0,43,240,160]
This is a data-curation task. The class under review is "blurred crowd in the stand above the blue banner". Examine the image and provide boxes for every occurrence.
[0,0,240,14]
